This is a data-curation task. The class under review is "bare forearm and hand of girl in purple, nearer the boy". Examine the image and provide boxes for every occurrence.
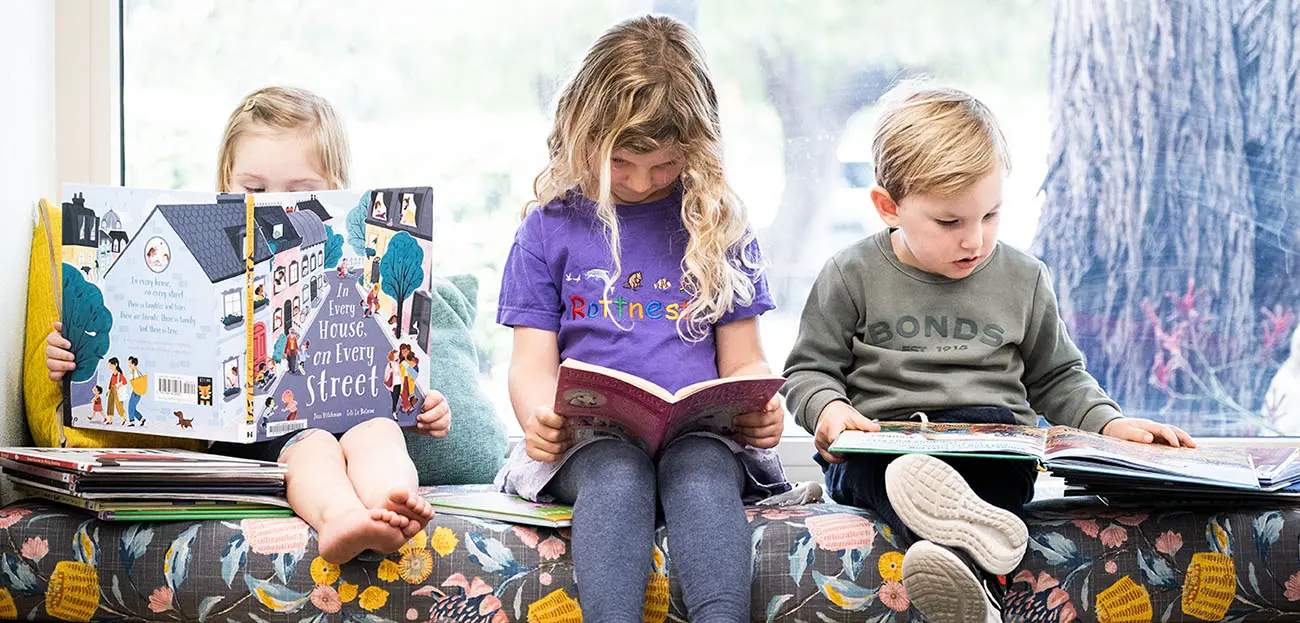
[715,317,785,447]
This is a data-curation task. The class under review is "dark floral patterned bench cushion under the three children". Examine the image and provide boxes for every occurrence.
[0,494,1300,623]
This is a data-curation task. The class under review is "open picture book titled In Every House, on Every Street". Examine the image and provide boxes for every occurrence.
[62,185,434,442]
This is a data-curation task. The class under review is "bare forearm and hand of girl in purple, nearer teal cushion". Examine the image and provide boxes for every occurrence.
[508,326,571,463]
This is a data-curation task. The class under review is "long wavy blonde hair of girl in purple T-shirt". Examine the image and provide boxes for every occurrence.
[524,16,759,341]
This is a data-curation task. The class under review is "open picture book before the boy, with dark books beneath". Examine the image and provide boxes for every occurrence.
[831,421,1300,503]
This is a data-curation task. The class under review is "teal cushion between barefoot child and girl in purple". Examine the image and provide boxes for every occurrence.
[406,274,507,485]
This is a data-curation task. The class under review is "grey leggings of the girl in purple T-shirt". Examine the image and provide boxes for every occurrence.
[546,437,751,623]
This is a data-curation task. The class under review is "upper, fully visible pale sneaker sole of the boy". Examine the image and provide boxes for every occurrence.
[885,454,1030,575]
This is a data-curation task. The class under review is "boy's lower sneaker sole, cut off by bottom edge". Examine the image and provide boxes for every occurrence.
[902,541,988,623]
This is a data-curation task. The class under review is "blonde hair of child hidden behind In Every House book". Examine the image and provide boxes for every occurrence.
[217,87,352,192]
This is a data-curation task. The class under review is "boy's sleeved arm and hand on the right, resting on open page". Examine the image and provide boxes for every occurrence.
[1021,265,1196,446]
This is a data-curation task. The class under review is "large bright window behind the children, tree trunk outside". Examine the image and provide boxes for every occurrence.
[124,0,1300,436]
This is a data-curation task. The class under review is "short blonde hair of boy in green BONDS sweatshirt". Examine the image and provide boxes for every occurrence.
[871,81,1011,202]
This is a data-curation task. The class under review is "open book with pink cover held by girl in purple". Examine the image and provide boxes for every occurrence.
[555,359,785,455]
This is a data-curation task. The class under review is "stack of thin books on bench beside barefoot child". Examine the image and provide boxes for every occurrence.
[0,447,293,520]
